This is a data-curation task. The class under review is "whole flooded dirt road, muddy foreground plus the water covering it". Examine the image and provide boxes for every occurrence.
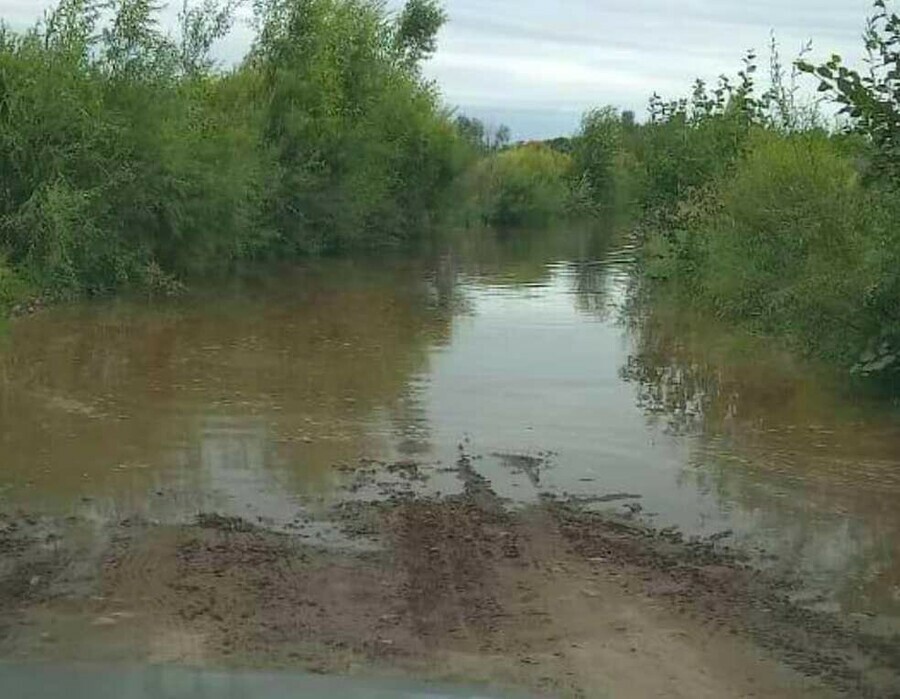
[0,233,900,697]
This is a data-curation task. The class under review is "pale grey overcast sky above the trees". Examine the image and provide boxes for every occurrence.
[0,0,871,138]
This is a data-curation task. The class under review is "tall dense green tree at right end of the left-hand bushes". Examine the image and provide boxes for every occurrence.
[250,0,455,252]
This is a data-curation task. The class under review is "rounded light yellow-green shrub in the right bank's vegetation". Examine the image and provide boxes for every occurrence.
[702,133,865,354]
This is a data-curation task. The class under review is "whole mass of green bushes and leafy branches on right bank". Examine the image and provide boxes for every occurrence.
[570,1,900,390]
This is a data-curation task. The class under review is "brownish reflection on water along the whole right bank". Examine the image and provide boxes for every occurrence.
[622,292,900,616]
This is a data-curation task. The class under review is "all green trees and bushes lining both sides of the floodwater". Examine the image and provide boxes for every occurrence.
[0,0,900,383]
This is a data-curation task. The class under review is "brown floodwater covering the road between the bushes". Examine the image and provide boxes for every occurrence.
[0,231,900,629]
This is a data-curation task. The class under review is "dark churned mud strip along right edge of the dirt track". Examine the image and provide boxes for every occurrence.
[545,498,900,698]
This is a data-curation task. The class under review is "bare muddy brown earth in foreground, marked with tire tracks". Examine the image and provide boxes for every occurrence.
[0,455,900,699]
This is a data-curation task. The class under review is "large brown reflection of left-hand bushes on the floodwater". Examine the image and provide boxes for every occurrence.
[0,261,452,504]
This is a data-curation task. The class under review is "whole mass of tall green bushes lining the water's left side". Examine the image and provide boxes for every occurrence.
[0,0,460,312]
